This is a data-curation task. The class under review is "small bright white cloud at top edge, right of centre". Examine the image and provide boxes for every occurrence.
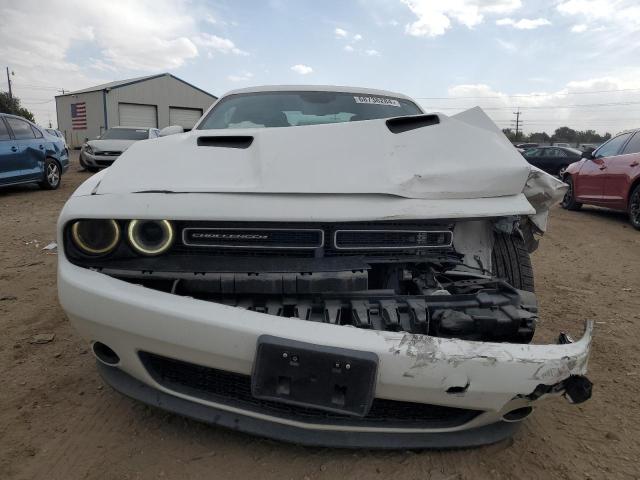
[401,0,522,37]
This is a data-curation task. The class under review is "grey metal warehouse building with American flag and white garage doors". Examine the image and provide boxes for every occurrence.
[56,73,216,148]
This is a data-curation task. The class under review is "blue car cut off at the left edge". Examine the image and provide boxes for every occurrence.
[0,113,69,190]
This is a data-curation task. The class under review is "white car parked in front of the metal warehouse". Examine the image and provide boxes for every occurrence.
[80,127,160,172]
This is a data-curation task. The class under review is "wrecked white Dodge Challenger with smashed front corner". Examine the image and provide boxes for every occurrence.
[58,86,592,448]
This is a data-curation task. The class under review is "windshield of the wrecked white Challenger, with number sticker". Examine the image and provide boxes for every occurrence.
[198,92,422,130]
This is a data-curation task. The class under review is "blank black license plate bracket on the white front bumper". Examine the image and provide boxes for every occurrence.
[251,335,378,417]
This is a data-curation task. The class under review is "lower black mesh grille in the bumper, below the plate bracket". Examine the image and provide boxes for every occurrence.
[139,352,482,428]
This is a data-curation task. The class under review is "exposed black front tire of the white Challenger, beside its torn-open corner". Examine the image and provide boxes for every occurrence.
[491,232,534,292]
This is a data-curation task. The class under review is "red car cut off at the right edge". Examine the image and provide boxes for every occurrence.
[561,129,640,230]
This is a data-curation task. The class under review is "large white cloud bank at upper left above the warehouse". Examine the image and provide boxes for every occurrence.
[0,0,246,123]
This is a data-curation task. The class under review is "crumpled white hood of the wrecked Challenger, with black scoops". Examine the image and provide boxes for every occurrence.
[94,108,556,199]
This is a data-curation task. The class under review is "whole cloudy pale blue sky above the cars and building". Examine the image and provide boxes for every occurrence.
[0,0,640,133]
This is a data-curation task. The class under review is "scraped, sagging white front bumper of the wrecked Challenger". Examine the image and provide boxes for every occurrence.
[58,256,592,448]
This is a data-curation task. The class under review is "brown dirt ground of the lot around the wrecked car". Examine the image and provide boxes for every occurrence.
[0,155,640,480]
